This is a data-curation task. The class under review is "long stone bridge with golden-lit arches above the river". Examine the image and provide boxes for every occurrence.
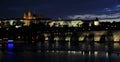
[45,31,120,42]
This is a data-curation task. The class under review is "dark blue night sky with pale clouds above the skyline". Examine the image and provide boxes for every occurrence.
[0,0,120,19]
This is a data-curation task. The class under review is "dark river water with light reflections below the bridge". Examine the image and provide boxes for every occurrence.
[0,42,120,62]
